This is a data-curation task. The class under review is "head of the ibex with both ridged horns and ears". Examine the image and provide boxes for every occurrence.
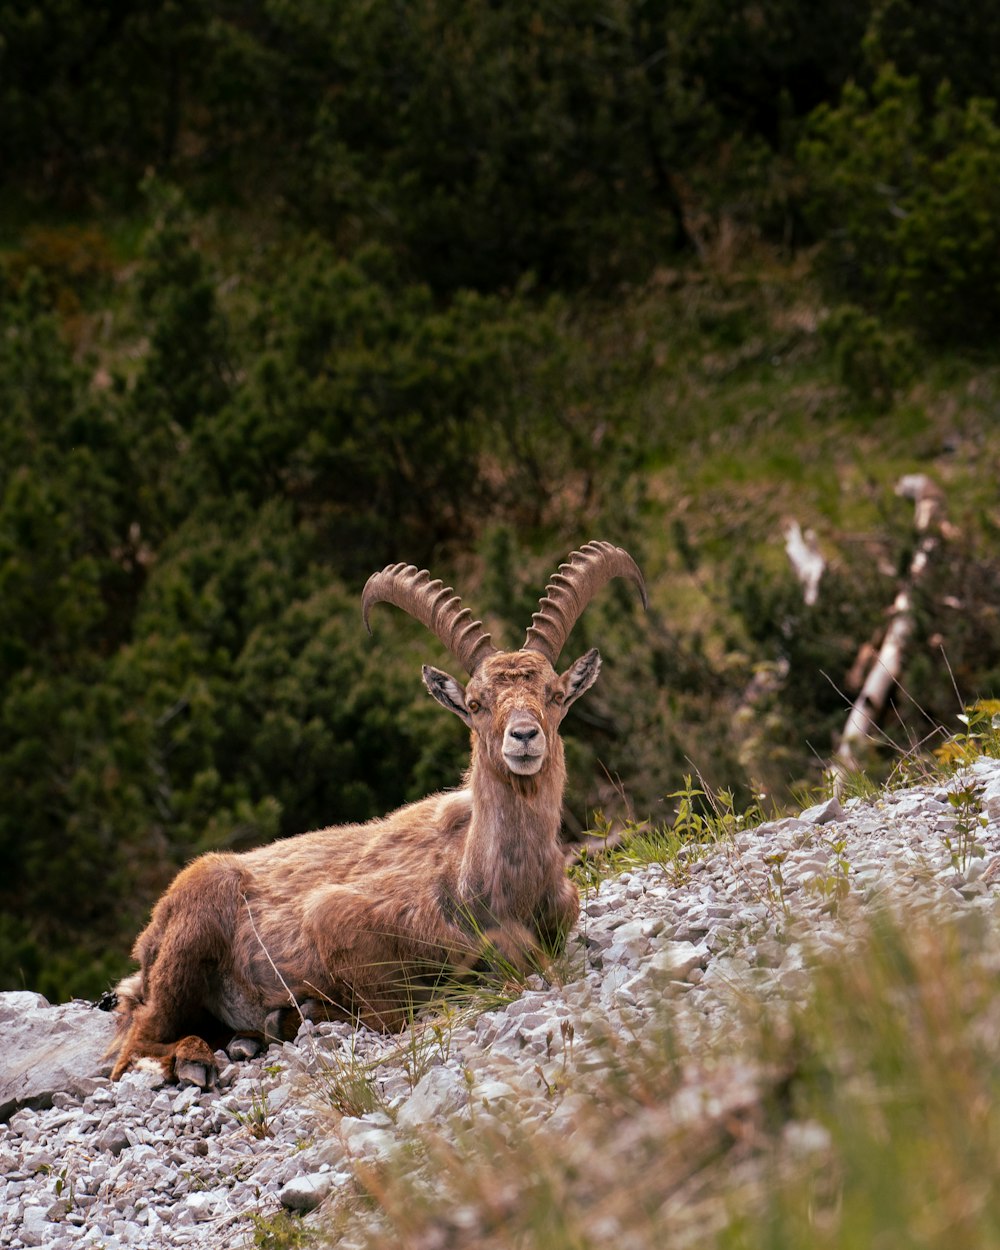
[361,543,646,778]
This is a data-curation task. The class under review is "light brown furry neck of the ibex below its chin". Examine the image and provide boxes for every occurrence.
[459,738,566,923]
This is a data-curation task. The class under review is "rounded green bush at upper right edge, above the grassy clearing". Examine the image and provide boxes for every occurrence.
[799,66,1000,343]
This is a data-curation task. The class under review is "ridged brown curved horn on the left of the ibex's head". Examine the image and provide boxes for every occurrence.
[361,564,496,676]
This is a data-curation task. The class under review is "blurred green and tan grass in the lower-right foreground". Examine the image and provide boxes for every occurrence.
[316,909,1000,1250]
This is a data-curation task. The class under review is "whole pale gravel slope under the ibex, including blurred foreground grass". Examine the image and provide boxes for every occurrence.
[0,758,1000,1250]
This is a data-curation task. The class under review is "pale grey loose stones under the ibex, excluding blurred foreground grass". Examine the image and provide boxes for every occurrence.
[0,759,1000,1250]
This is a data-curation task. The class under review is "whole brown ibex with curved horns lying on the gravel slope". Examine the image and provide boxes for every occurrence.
[113,541,646,1088]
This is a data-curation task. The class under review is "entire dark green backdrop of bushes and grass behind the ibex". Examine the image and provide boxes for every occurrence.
[0,0,1000,996]
